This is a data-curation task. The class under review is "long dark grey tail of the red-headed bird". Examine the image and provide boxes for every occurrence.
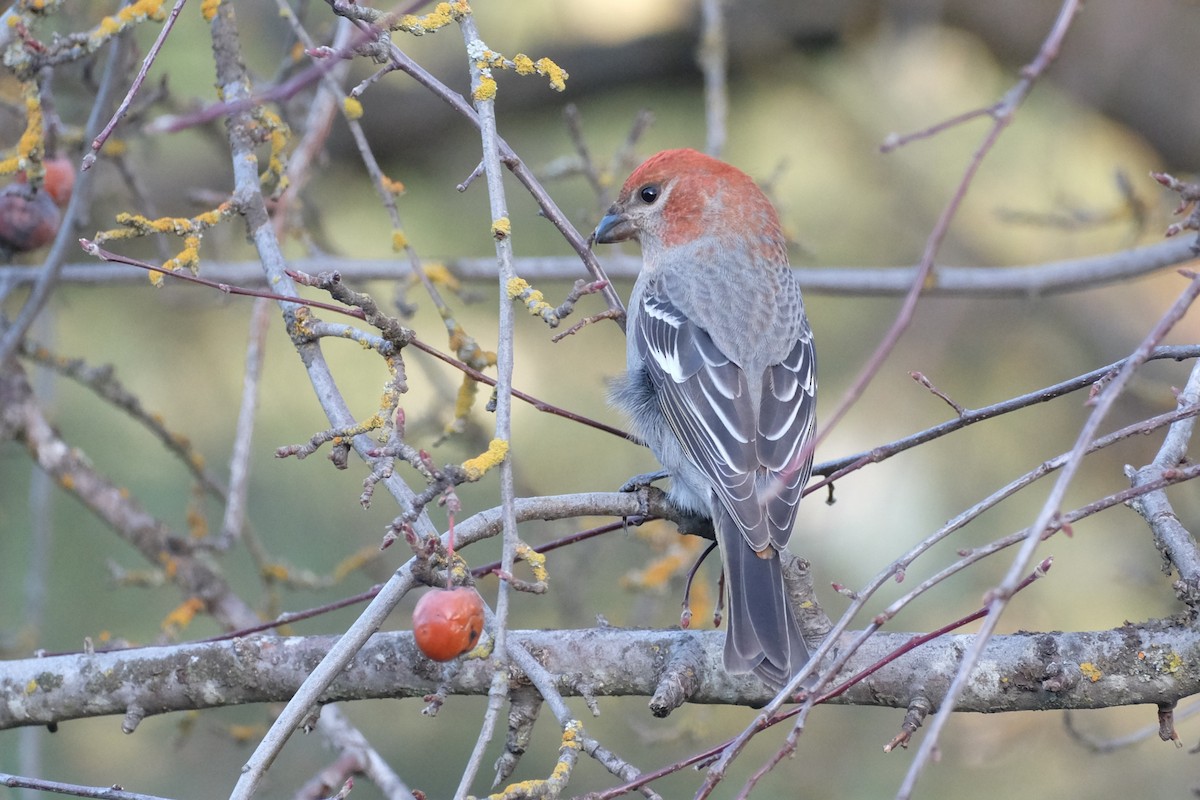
[714,511,809,688]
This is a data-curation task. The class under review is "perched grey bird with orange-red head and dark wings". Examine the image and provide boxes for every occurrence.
[593,150,817,688]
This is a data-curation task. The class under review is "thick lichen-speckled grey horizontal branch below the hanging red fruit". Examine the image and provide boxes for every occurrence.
[0,622,1200,729]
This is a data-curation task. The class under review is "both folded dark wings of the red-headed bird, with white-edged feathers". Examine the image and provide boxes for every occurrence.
[630,283,816,551]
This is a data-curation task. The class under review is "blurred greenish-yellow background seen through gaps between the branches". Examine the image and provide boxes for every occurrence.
[0,0,1200,799]
